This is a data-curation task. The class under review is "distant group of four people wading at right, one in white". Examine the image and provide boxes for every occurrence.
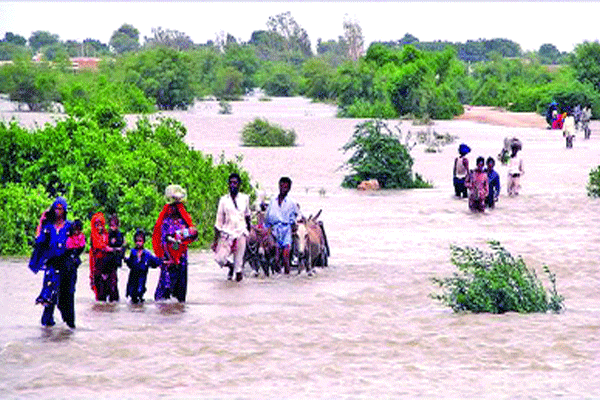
[453,138,525,212]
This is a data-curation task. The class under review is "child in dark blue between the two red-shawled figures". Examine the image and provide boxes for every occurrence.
[125,229,162,304]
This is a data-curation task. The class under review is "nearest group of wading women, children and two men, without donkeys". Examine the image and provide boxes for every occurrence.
[29,173,299,328]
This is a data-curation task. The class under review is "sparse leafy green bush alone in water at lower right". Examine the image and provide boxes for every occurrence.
[431,241,564,314]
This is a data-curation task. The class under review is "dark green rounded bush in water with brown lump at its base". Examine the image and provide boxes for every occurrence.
[342,120,431,189]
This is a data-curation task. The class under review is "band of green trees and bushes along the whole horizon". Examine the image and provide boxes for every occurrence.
[0,13,600,119]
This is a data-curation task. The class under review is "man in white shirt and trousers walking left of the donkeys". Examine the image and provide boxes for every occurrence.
[212,173,251,282]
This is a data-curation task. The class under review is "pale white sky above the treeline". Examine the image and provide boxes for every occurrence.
[0,0,600,52]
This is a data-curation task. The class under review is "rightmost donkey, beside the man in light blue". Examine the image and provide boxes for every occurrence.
[295,211,329,276]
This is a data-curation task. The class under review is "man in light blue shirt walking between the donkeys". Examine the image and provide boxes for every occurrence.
[265,176,299,274]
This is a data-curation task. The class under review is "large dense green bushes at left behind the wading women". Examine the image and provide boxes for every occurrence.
[0,106,252,255]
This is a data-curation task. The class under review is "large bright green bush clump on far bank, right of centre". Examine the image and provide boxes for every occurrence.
[337,44,465,119]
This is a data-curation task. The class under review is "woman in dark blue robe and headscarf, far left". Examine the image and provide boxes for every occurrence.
[29,197,77,328]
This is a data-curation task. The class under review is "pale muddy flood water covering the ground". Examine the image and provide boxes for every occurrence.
[0,98,600,399]
